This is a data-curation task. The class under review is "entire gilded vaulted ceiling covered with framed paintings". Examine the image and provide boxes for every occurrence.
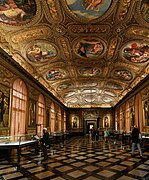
[0,0,149,108]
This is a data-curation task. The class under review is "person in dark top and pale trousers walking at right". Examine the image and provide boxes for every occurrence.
[131,125,142,157]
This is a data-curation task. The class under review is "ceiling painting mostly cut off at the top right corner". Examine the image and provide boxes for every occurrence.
[141,0,149,23]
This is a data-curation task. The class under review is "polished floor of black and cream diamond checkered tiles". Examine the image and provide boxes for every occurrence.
[0,137,149,180]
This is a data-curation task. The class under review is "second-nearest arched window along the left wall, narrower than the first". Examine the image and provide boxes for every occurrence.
[37,94,45,136]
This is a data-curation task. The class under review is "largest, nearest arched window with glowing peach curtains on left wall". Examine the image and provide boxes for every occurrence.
[10,79,27,136]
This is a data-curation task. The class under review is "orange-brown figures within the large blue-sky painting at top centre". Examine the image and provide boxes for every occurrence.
[83,0,104,11]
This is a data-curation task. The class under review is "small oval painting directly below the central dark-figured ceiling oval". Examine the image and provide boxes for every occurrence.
[79,67,100,76]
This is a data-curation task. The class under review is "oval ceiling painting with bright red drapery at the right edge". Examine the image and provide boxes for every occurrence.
[122,42,149,63]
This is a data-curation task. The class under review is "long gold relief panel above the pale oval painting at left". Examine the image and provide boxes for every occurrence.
[11,26,52,43]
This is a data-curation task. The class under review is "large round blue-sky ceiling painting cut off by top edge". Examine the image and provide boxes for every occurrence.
[66,0,112,20]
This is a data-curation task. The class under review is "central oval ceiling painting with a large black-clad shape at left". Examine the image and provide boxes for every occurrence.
[74,38,105,58]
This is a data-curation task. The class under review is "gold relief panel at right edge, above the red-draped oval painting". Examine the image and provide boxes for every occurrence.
[126,26,149,39]
